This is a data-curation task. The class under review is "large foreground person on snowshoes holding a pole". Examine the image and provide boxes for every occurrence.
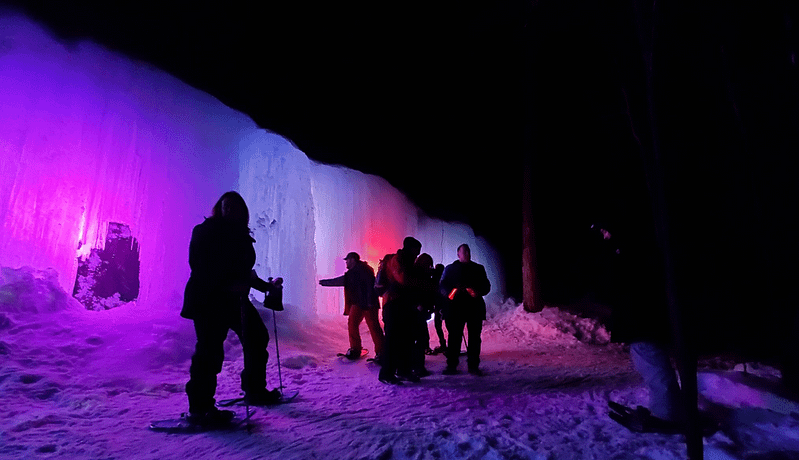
[180,192,283,425]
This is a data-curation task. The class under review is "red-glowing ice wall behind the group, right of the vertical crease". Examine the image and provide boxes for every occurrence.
[311,164,504,314]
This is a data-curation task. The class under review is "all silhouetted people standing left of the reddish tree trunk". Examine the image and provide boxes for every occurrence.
[180,192,491,425]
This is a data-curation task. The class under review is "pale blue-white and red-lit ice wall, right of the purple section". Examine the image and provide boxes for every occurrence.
[239,135,504,315]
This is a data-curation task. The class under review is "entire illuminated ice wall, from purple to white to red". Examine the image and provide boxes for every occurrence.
[0,13,503,314]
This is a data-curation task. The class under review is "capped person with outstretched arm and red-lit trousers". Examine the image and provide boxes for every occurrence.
[319,252,384,362]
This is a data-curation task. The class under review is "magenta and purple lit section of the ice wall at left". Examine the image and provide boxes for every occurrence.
[0,15,247,310]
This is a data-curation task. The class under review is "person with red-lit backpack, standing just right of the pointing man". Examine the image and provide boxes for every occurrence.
[375,236,422,385]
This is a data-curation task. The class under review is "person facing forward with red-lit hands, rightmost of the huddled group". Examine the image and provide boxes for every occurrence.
[440,244,491,375]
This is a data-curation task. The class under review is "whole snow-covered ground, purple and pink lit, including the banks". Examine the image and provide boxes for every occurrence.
[0,268,799,460]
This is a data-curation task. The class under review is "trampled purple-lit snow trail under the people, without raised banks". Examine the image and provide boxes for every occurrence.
[0,292,679,459]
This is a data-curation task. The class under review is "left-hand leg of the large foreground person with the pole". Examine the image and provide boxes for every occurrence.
[191,318,228,415]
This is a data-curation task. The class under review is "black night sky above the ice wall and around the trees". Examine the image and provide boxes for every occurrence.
[4,0,799,344]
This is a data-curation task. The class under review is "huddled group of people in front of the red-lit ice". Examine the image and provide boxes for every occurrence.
[319,236,491,384]
